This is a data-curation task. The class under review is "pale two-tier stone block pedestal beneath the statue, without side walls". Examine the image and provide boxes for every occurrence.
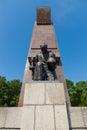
[21,82,69,130]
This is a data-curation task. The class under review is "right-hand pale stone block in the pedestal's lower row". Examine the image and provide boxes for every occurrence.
[55,105,69,130]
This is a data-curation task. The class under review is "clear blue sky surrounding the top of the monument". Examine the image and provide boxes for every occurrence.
[0,0,87,82]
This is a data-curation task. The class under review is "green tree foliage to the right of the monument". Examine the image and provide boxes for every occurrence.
[66,79,87,106]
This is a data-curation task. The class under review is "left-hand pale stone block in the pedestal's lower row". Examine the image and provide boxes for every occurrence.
[21,106,34,130]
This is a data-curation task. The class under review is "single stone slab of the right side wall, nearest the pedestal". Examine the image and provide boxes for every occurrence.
[70,107,85,128]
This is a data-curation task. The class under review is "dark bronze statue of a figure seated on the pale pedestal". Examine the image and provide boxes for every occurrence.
[29,43,57,81]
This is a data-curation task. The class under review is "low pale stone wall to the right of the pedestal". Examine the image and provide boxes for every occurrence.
[69,107,87,130]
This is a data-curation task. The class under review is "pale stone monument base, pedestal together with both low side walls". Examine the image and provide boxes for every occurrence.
[0,81,87,130]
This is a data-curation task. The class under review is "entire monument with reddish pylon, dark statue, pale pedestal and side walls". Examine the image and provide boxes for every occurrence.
[0,7,87,130]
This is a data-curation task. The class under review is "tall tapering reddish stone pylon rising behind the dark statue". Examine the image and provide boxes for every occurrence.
[19,7,70,106]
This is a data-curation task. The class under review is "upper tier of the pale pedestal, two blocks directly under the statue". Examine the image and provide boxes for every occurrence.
[24,82,65,105]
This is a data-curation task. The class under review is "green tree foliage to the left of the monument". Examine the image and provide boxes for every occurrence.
[0,76,22,107]
